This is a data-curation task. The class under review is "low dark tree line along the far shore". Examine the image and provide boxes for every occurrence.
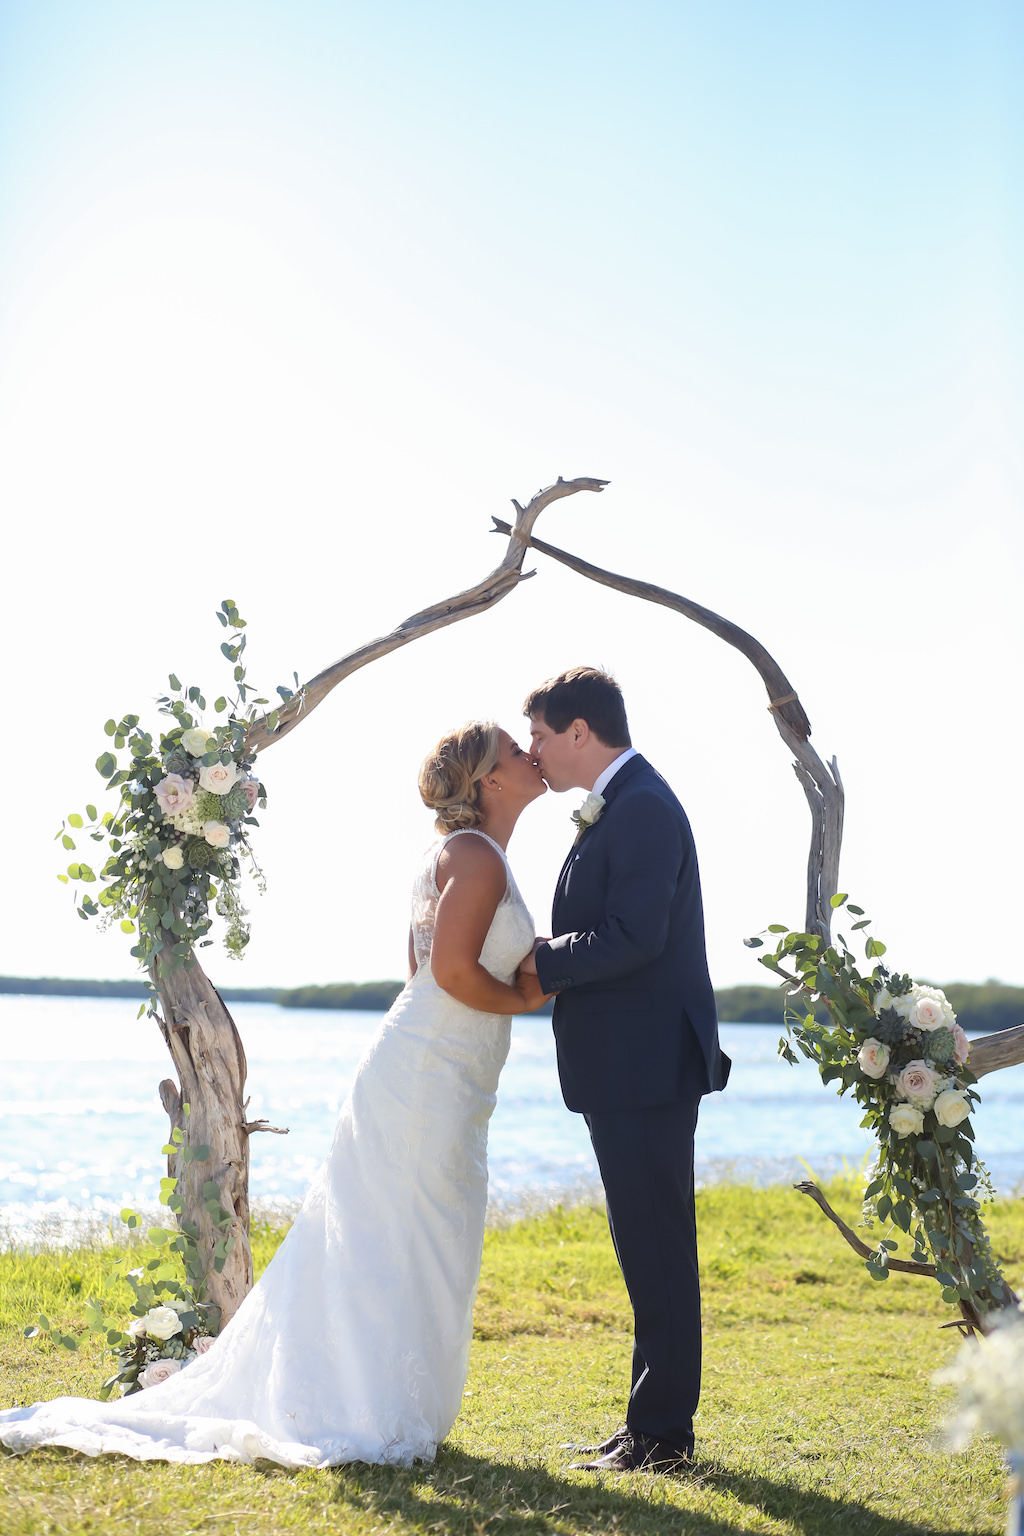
[0,975,1024,1034]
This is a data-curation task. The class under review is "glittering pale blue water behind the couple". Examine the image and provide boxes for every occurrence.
[0,995,1024,1235]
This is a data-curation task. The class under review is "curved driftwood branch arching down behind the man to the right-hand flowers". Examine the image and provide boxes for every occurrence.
[491,518,843,940]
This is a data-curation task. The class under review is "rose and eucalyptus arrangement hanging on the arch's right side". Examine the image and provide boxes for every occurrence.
[746,894,1015,1321]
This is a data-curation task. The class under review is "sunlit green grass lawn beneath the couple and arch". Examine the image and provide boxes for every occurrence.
[0,1183,1024,1536]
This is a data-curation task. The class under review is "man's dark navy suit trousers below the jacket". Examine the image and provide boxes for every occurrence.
[583,1098,700,1455]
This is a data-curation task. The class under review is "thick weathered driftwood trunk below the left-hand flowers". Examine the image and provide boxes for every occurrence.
[154,963,255,1324]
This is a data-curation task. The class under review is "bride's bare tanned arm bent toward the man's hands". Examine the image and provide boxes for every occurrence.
[430,837,543,1014]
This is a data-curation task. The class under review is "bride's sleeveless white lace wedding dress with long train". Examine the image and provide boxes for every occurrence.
[0,833,533,1467]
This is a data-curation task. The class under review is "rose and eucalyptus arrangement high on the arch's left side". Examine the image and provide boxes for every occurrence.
[57,599,301,969]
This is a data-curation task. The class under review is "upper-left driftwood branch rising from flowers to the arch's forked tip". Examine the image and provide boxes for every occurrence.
[246,476,608,751]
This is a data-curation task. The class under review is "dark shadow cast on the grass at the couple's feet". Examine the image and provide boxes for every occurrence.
[254,1448,994,1536]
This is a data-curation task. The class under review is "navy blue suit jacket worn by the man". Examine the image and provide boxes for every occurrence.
[537,756,731,1114]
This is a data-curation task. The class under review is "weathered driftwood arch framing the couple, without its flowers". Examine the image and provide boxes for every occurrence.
[154,476,1024,1321]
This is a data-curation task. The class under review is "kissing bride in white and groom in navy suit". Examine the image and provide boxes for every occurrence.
[0,667,729,1471]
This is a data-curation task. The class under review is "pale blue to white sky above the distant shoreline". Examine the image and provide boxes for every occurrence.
[0,0,1024,985]
